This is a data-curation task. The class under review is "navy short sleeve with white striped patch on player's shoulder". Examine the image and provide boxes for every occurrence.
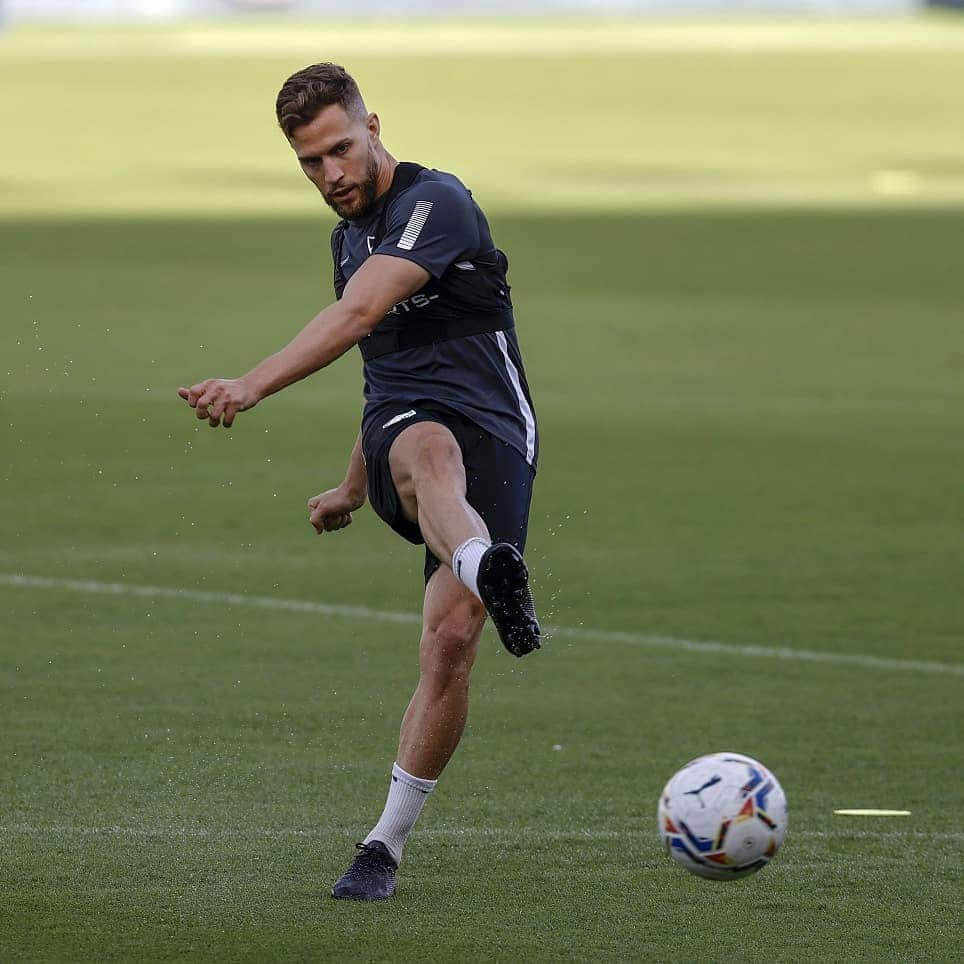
[372,181,479,278]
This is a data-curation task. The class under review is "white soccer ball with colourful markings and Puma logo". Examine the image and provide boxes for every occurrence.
[657,753,787,880]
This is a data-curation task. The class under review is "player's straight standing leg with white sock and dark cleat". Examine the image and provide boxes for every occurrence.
[332,566,485,900]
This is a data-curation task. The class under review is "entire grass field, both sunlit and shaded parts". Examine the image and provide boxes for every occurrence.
[0,20,964,961]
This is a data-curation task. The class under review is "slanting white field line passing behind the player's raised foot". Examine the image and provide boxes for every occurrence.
[0,573,964,676]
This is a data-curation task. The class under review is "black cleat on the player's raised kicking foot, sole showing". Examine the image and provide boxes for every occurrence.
[477,542,542,656]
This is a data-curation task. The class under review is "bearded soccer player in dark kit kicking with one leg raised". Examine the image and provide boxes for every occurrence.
[178,64,541,900]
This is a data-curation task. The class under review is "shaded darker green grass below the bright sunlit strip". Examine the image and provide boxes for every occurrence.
[0,212,964,960]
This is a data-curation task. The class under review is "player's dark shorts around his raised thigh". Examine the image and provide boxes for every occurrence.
[362,404,535,583]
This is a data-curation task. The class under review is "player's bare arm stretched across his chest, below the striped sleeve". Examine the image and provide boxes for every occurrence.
[178,254,429,428]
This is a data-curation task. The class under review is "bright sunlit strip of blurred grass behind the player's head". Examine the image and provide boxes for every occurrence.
[0,17,964,217]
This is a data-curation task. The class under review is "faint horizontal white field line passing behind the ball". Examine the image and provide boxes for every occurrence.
[0,824,964,842]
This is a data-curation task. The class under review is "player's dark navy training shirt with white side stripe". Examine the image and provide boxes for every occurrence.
[333,169,539,468]
